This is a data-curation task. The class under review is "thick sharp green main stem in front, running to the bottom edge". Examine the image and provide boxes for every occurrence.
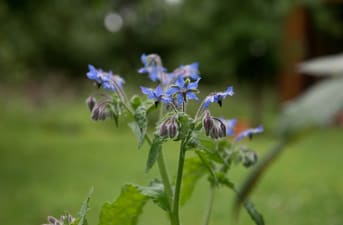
[172,140,186,225]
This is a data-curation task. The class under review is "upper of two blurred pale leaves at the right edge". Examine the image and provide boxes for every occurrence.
[298,53,343,76]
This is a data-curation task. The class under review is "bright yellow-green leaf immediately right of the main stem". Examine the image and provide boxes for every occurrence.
[180,157,207,205]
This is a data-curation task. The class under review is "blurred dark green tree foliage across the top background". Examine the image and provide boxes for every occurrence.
[0,0,341,83]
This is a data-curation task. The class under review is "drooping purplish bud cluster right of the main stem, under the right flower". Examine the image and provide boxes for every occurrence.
[203,110,226,139]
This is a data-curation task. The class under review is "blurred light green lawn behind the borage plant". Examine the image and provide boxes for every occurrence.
[0,92,343,225]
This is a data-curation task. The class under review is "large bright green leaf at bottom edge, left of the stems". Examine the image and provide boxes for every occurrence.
[99,184,149,225]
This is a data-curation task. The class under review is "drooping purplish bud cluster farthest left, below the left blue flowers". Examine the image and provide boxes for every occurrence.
[86,96,111,120]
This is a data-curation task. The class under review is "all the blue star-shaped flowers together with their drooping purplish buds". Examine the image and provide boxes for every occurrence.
[87,54,263,142]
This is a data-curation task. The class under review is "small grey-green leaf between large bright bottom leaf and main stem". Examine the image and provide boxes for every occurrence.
[138,180,170,211]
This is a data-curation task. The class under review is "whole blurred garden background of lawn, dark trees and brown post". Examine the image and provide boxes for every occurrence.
[0,0,343,225]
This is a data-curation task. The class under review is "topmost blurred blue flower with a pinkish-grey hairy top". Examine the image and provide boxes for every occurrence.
[138,54,166,82]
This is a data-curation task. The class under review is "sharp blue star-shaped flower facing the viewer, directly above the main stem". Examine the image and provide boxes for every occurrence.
[166,76,200,105]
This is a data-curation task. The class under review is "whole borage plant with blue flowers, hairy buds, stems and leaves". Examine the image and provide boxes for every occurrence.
[43,54,264,225]
